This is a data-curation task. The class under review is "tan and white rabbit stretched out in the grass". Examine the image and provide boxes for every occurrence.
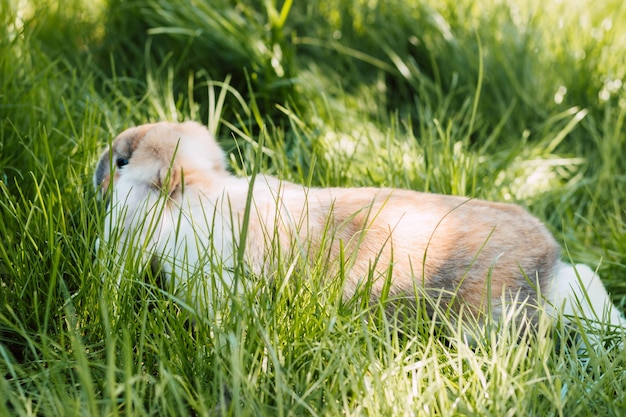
[94,121,626,338]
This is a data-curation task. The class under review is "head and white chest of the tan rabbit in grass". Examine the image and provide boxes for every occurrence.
[93,122,235,304]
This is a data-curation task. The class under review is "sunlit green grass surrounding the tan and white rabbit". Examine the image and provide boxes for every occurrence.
[0,0,626,417]
